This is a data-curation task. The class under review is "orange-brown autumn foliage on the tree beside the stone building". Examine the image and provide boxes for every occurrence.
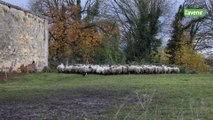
[49,1,102,62]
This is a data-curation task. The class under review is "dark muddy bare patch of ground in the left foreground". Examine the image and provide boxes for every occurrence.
[0,89,140,120]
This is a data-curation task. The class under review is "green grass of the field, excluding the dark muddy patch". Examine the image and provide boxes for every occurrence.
[0,73,213,120]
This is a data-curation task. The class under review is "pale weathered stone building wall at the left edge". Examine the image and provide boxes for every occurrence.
[0,0,48,72]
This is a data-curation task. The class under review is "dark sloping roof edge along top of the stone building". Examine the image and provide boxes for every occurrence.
[0,0,46,19]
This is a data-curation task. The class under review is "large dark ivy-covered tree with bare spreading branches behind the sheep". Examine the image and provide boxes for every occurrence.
[108,0,171,62]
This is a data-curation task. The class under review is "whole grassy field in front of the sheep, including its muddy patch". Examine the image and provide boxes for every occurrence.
[0,73,213,120]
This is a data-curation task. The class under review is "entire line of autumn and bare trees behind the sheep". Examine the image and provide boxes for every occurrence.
[30,0,213,71]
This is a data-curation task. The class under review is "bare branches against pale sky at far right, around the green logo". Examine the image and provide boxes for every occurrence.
[185,0,213,51]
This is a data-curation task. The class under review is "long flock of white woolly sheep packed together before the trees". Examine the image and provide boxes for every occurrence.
[57,64,180,75]
